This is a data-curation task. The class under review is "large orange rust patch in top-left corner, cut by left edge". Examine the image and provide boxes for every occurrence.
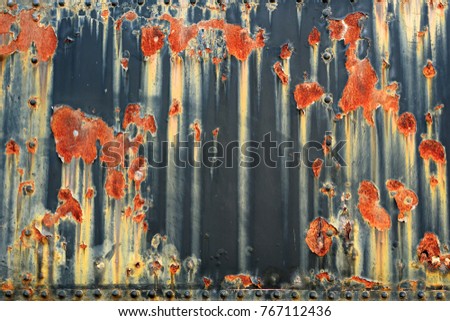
[0,9,58,61]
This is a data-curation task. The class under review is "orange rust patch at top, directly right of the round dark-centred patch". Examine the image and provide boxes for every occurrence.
[161,14,198,53]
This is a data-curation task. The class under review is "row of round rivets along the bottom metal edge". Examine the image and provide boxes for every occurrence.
[3,289,445,301]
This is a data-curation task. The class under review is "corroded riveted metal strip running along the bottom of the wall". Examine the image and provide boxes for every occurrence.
[0,288,450,301]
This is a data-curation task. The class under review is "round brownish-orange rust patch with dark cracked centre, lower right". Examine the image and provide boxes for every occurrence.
[305,217,338,256]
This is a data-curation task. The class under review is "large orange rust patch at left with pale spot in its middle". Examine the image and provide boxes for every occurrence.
[50,106,114,164]
